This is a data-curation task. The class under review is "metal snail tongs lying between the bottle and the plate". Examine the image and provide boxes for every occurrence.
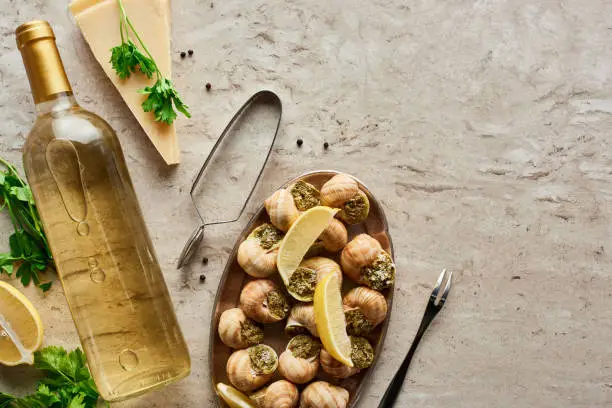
[176,90,283,269]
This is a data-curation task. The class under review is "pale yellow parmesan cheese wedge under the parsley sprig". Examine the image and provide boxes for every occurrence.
[70,0,180,164]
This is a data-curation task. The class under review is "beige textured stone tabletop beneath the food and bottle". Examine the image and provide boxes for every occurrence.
[0,0,612,408]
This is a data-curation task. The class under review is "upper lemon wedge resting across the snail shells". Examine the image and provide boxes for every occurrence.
[276,205,339,301]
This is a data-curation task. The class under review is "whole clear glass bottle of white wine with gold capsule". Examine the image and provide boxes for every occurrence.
[16,21,190,401]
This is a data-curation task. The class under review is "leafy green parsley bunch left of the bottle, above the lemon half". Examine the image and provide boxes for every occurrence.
[0,158,54,290]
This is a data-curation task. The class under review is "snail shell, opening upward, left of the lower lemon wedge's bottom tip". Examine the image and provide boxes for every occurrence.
[278,334,321,384]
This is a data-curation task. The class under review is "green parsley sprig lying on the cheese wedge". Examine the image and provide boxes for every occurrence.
[110,0,191,125]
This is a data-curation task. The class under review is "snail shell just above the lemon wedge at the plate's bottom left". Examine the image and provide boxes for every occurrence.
[226,344,278,392]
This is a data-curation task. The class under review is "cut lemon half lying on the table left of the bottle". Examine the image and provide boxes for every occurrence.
[0,281,43,366]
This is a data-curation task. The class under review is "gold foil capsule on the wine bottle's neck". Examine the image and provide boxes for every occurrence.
[15,20,72,104]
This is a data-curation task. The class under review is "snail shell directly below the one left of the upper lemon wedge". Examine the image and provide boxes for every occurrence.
[240,279,289,323]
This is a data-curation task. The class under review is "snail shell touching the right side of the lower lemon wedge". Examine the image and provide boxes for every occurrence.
[342,286,387,336]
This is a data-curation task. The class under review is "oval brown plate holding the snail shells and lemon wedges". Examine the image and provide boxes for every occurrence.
[209,170,393,408]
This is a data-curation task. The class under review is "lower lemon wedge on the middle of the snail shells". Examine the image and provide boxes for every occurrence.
[314,274,353,367]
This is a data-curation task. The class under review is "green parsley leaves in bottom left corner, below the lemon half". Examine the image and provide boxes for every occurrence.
[0,346,108,408]
